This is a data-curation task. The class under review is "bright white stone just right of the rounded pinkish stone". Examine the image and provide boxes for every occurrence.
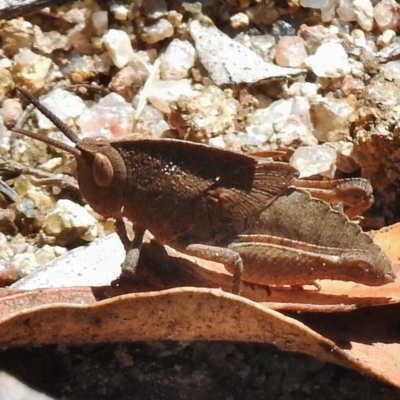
[305,42,351,78]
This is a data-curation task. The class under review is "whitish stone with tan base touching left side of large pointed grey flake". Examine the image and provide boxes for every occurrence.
[160,39,196,80]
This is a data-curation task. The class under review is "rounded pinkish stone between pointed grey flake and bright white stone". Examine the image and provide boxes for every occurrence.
[275,36,308,67]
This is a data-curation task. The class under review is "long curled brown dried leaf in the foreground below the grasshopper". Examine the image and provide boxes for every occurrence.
[0,287,400,387]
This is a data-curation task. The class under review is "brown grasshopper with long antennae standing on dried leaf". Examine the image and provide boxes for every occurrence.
[10,89,394,293]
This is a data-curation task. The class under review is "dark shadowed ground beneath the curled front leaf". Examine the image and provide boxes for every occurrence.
[0,342,400,400]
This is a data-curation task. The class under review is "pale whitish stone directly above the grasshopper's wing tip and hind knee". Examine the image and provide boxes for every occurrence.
[289,144,337,179]
